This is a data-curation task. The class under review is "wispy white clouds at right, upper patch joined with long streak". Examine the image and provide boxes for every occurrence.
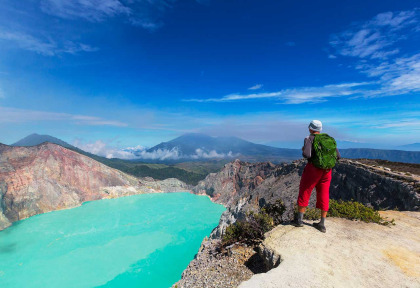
[183,9,420,104]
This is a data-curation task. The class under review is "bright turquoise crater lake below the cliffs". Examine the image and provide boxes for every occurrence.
[0,193,225,288]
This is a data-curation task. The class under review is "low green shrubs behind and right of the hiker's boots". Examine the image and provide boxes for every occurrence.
[304,200,395,225]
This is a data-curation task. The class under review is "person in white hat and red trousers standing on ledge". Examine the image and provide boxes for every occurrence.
[294,120,341,233]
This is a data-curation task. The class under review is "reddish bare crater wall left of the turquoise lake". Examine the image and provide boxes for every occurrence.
[0,143,137,230]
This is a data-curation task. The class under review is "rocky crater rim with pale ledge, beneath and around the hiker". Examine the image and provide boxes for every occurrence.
[173,159,420,288]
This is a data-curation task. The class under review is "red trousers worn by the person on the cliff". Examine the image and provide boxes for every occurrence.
[298,163,331,211]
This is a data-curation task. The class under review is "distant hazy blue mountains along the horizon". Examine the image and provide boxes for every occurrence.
[13,133,420,164]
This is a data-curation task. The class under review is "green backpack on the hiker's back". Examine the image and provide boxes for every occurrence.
[311,133,337,169]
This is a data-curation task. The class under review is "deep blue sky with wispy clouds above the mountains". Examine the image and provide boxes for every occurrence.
[0,0,420,158]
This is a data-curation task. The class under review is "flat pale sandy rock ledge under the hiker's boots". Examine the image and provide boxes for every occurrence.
[239,211,420,288]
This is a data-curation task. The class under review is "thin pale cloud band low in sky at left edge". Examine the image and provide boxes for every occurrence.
[0,107,127,127]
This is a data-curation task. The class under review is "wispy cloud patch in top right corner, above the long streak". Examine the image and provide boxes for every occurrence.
[330,10,419,59]
